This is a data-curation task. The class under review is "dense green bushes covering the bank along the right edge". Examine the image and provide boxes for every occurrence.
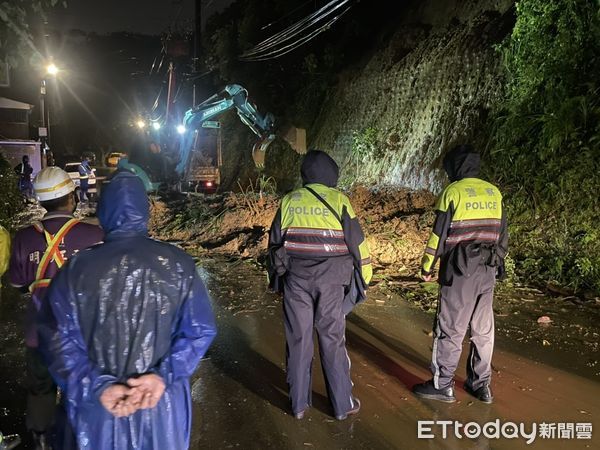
[486,0,600,292]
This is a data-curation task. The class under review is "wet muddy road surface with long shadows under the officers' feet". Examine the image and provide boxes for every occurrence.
[0,260,600,449]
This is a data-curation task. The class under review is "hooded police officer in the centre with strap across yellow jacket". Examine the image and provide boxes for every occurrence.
[269,150,372,420]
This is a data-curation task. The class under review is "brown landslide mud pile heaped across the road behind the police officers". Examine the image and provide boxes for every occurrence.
[150,187,435,275]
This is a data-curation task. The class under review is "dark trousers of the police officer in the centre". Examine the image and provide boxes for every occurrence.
[283,273,354,415]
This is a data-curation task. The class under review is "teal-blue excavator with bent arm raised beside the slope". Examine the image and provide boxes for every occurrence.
[119,84,306,192]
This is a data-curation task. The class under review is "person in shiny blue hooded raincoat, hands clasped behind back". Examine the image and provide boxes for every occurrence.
[39,172,216,450]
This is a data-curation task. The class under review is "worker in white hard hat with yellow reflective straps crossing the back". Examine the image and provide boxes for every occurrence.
[8,167,104,450]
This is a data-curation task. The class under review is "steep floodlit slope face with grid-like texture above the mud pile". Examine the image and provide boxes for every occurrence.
[310,0,513,191]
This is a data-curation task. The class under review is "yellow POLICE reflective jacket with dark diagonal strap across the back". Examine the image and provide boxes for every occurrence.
[269,183,373,290]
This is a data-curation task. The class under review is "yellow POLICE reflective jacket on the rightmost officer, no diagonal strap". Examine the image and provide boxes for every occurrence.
[421,178,508,284]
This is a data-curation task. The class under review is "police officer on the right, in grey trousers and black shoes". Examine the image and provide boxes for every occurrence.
[413,145,508,403]
